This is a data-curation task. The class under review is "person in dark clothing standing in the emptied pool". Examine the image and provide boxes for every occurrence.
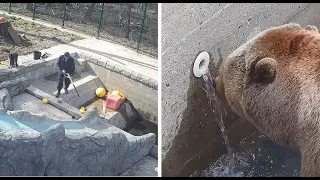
[56,52,75,98]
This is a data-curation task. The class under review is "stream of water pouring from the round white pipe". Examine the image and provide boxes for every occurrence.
[202,69,240,177]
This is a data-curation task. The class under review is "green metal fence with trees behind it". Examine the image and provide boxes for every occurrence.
[0,3,158,56]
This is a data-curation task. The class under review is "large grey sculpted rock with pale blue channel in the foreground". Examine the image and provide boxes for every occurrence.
[0,107,156,176]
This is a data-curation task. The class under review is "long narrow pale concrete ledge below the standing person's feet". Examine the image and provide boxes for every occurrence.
[26,85,82,119]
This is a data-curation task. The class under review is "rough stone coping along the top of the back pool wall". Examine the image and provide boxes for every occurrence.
[78,53,158,90]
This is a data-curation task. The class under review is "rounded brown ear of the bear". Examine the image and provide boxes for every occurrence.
[255,58,277,83]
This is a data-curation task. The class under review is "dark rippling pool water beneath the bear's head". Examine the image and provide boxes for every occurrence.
[196,128,301,177]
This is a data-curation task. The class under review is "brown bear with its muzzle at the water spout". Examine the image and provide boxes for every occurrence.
[215,23,320,176]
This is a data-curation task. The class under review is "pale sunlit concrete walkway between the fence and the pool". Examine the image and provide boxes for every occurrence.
[13,38,158,80]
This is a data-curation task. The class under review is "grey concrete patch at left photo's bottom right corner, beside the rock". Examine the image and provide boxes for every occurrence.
[120,156,158,177]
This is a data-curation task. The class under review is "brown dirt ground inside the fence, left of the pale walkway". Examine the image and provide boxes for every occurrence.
[0,14,83,68]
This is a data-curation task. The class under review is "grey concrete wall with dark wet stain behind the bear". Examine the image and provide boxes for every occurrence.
[161,3,320,176]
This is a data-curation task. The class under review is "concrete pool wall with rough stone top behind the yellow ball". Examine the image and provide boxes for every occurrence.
[79,53,158,124]
